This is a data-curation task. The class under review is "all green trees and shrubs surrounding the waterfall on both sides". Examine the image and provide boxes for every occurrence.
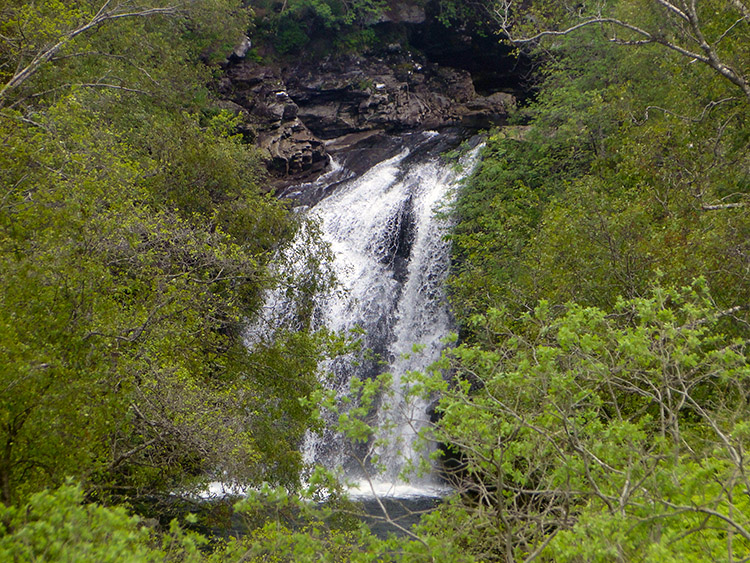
[0,0,750,561]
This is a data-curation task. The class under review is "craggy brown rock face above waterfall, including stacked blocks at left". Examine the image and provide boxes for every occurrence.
[220,33,515,194]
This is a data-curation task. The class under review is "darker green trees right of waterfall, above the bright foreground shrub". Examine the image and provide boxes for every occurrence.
[451,24,750,344]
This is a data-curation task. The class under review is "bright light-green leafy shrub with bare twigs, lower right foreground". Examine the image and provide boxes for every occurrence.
[412,280,750,561]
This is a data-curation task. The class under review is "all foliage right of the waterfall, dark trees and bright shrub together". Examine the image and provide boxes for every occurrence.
[440,1,750,561]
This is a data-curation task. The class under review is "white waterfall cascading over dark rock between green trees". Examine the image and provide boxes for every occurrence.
[305,133,478,496]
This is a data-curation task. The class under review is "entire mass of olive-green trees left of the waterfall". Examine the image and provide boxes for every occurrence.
[0,2,330,504]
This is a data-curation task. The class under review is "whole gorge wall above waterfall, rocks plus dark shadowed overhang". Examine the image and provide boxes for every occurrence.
[214,0,523,203]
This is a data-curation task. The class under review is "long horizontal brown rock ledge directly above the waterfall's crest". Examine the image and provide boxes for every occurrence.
[284,52,513,139]
